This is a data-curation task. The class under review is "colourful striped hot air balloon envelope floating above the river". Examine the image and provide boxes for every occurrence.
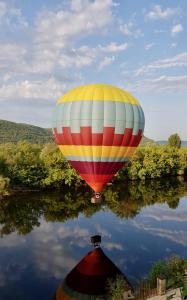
[53,84,144,196]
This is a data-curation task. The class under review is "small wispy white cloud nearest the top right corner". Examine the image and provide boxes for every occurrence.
[145,5,179,21]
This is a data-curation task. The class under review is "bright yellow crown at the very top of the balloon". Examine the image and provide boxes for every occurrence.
[57,84,140,105]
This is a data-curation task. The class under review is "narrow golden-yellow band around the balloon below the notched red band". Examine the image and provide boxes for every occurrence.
[59,145,136,159]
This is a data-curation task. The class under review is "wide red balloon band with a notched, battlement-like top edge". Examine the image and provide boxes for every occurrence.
[53,127,142,147]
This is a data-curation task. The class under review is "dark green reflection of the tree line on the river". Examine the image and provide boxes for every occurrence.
[0,179,187,235]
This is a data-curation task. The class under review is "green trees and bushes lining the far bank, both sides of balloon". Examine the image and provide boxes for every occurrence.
[0,134,187,197]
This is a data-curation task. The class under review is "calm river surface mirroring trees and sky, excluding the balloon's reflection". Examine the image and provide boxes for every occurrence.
[0,179,187,300]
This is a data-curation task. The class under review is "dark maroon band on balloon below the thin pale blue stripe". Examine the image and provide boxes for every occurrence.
[69,160,124,175]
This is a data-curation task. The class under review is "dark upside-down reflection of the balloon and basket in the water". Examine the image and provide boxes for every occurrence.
[56,235,133,300]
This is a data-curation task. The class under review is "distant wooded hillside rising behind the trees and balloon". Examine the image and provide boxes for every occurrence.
[0,120,154,145]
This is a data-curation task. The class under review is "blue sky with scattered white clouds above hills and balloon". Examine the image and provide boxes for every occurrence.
[0,0,187,140]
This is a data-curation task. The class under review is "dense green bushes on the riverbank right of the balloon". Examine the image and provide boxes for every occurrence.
[119,144,187,180]
